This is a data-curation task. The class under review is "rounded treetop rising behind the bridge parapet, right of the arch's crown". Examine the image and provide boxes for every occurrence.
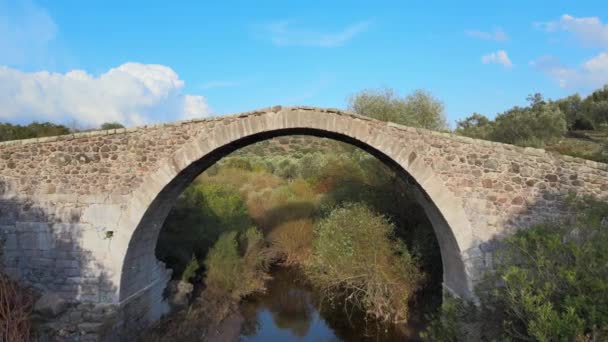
[348,89,447,130]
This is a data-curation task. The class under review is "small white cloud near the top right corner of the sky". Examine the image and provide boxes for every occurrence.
[536,14,608,47]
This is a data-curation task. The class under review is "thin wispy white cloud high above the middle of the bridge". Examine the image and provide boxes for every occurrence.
[264,20,370,47]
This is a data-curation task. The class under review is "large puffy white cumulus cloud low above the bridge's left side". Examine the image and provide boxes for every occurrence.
[0,63,210,126]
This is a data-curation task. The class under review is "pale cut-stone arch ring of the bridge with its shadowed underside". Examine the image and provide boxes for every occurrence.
[118,108,474,326]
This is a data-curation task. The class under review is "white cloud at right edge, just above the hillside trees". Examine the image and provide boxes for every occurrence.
[530,52,608,89]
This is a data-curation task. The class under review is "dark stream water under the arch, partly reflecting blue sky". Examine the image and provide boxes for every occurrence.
[240,269,420,342]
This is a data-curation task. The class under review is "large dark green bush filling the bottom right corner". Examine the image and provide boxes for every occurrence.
[486,199,608,341]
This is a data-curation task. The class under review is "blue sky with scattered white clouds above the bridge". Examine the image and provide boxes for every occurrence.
[0,0,608,126]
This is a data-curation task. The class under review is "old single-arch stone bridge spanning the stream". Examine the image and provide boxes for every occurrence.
[0,107,608,336]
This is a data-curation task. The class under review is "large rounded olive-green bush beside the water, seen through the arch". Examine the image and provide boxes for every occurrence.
[306,204,424,322]
